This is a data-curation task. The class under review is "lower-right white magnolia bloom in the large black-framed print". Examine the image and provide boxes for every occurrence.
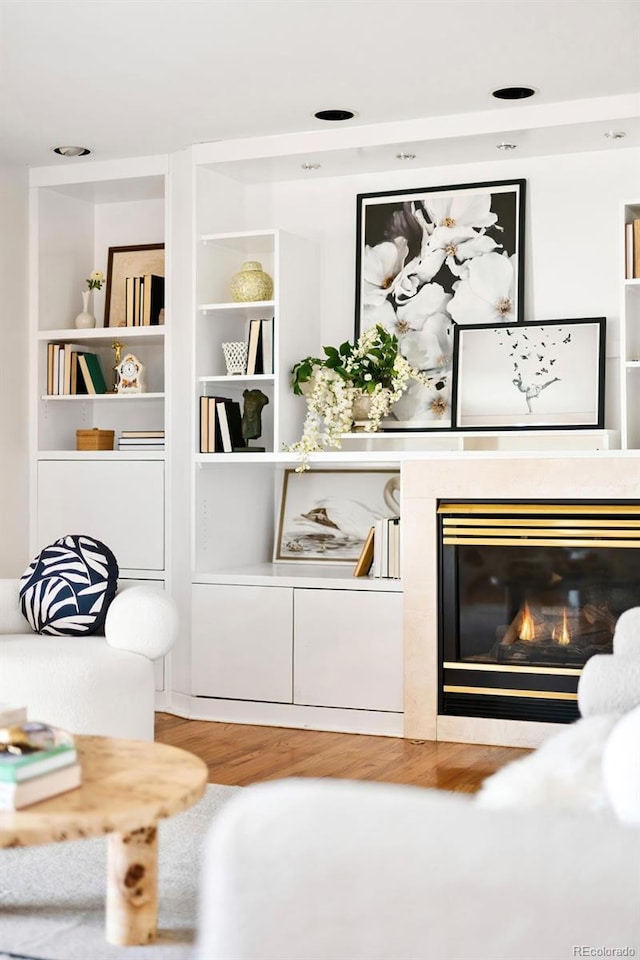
[449,253,516,324]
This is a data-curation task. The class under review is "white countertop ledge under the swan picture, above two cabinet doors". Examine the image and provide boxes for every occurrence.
[193,560,402,593]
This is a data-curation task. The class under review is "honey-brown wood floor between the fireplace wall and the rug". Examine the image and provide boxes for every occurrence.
[156,713,530,793]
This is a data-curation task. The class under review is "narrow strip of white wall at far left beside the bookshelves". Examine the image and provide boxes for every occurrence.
[0,165,30,577]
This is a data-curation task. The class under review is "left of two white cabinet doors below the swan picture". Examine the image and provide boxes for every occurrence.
[191,584,293,703]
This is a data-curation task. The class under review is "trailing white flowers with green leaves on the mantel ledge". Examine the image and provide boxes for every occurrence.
[285,324,433,472]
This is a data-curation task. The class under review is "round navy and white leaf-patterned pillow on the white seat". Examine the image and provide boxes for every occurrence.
[20,535,118,636]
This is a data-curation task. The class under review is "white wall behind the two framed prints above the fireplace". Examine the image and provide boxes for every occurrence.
[246,149,640,429]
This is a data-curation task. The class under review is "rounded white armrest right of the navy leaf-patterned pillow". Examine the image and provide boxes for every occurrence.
[104,586,178,660]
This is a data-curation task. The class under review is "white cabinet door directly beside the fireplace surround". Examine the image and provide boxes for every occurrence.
[293,589,403,713]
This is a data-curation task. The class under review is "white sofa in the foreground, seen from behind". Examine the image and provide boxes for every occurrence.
[195,609,640,960]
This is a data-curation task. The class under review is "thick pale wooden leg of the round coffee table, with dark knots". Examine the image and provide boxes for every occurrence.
[106,826,158,947]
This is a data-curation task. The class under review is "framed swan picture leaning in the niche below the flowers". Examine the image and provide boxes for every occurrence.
[273,470,400,564]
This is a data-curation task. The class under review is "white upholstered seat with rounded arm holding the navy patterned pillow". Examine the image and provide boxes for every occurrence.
[0,580,178,740]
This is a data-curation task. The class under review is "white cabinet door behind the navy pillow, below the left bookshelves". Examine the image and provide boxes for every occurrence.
[37,460,164,570]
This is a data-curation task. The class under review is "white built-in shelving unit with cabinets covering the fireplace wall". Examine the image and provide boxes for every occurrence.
[31,98,640,735]
